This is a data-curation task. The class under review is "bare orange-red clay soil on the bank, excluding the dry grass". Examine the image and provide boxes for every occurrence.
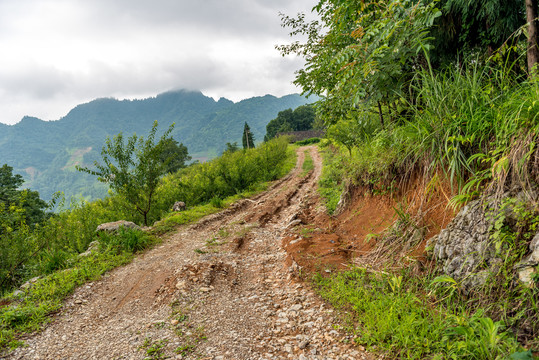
[283,172,453,275]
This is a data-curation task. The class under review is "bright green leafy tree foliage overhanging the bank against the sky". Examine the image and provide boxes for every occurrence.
[278,0,440,123]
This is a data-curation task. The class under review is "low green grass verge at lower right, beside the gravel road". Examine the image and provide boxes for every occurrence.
[313,268,533,360]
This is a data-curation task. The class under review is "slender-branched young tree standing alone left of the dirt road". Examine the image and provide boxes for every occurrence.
[77,121,174,226]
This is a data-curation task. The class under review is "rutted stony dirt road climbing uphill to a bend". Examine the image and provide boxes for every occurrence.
[8,147,368,360]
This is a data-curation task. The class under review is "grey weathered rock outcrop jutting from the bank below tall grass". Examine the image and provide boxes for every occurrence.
[427,193,539,293]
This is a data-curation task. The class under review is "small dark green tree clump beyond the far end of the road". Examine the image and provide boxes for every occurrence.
[264,105,316,141]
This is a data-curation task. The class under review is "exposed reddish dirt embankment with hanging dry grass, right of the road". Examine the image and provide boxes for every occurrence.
[283,172,453,274]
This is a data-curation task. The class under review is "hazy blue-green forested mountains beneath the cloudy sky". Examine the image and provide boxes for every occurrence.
[0,90,307,199]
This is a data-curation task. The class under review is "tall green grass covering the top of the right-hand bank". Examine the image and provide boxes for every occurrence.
[329,61,539,202]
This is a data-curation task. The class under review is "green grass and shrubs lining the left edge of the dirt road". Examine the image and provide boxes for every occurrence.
[0,135,294,356]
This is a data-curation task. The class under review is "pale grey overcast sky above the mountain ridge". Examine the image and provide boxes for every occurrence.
[0,0,318,124]
